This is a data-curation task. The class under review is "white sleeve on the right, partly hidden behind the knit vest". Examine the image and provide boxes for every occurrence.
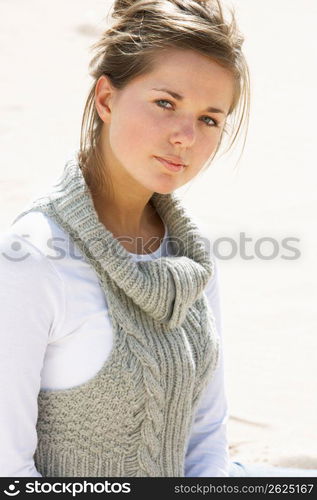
[185,252,229,477]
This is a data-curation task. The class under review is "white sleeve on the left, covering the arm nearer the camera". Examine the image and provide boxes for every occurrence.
[0,231,64,477]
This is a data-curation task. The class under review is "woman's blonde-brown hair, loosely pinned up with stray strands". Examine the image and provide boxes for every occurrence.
[78,0,250,192]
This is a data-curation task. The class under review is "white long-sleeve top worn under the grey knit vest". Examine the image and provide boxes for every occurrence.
[0,212,229,477]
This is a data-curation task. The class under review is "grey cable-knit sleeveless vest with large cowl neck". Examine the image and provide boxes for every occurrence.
[15,156,219,477]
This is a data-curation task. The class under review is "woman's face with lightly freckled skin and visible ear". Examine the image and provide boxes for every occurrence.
[96,49,234,194]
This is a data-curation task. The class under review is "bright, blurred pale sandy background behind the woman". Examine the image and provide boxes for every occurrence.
[0,0,317,468]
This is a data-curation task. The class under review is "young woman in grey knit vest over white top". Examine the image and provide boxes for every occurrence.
[0,0,313,477]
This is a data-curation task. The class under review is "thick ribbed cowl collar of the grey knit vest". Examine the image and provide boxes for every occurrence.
[24,156,214,330]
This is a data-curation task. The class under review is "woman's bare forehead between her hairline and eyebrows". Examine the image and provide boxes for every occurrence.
[132,49,234,107]
